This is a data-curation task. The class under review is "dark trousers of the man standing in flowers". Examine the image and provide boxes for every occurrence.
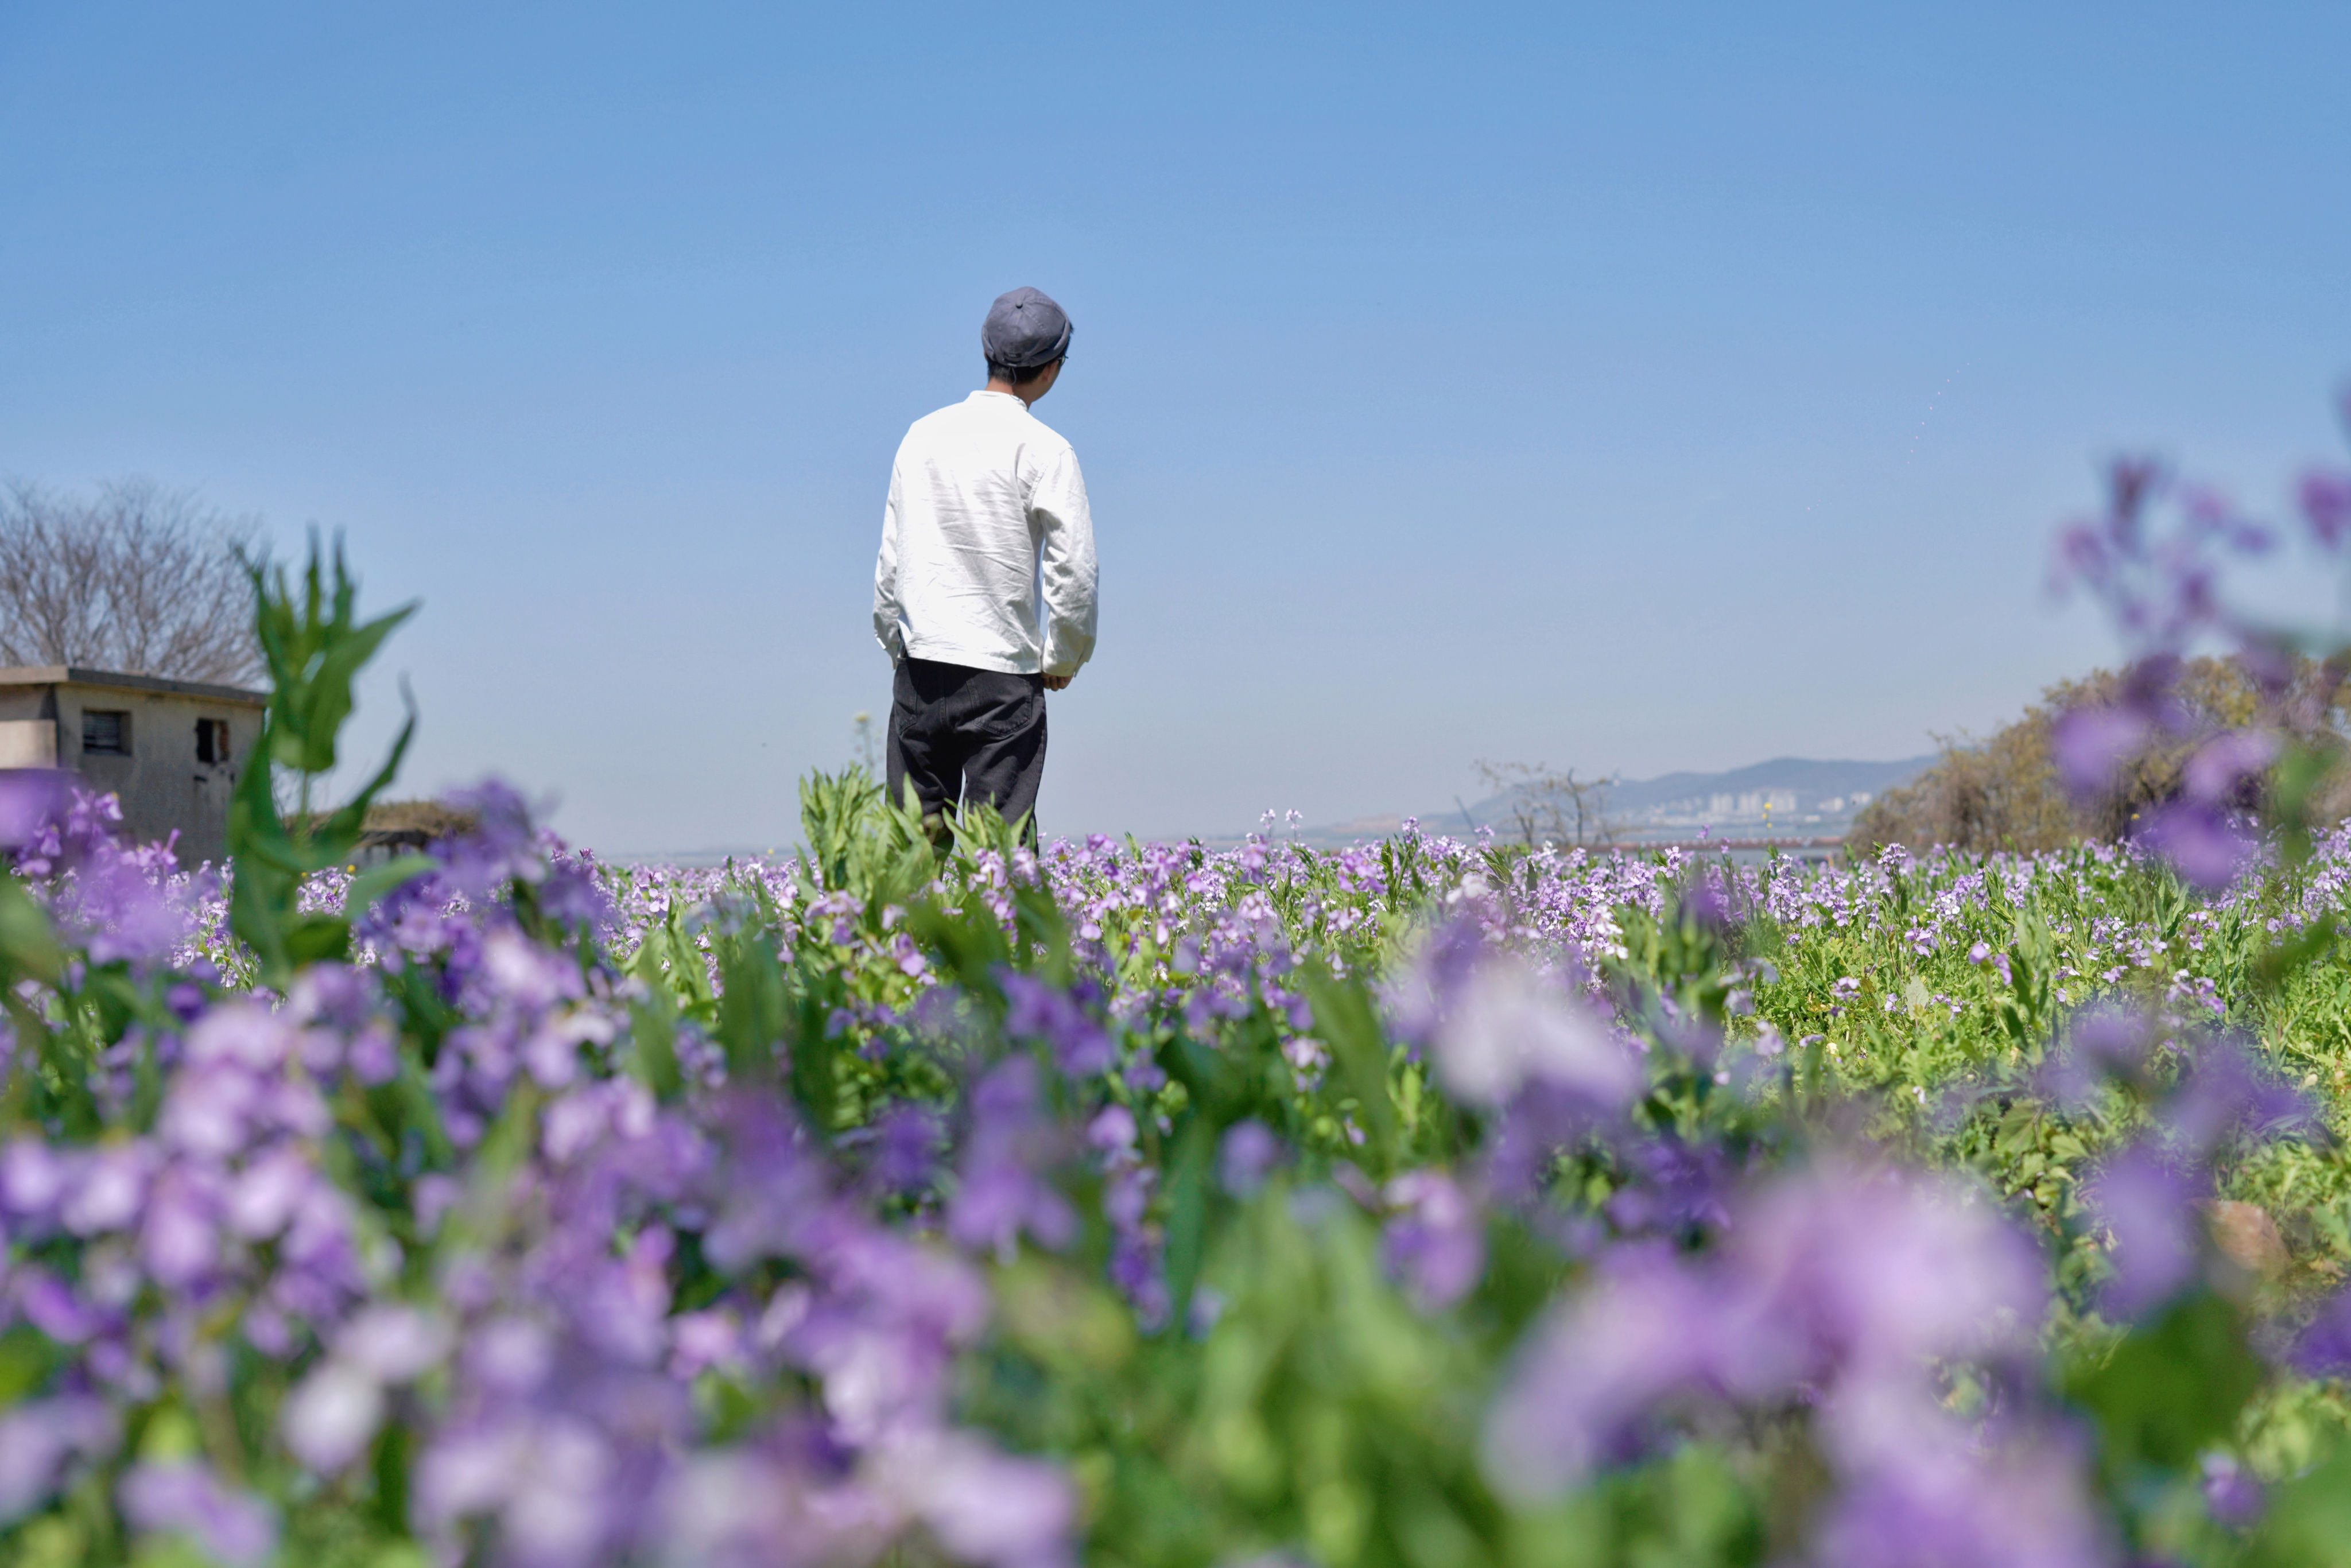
[889,658,1044,844]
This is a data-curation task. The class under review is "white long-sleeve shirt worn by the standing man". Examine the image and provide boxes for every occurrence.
[875,393,1096,675]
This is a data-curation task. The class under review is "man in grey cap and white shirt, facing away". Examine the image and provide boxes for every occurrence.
[875,289,1093,844]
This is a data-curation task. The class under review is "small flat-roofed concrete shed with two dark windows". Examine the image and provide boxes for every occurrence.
[0,665,268,865]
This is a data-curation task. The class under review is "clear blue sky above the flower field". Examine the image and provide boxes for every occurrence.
[0,0,2351,851]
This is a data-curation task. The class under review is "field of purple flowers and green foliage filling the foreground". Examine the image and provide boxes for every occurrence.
[0,500,2351,1568]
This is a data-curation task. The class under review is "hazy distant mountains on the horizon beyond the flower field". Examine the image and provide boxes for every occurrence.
[1260,757,1935,847]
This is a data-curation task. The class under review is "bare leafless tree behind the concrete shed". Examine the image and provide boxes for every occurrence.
[0,480,263,684]
